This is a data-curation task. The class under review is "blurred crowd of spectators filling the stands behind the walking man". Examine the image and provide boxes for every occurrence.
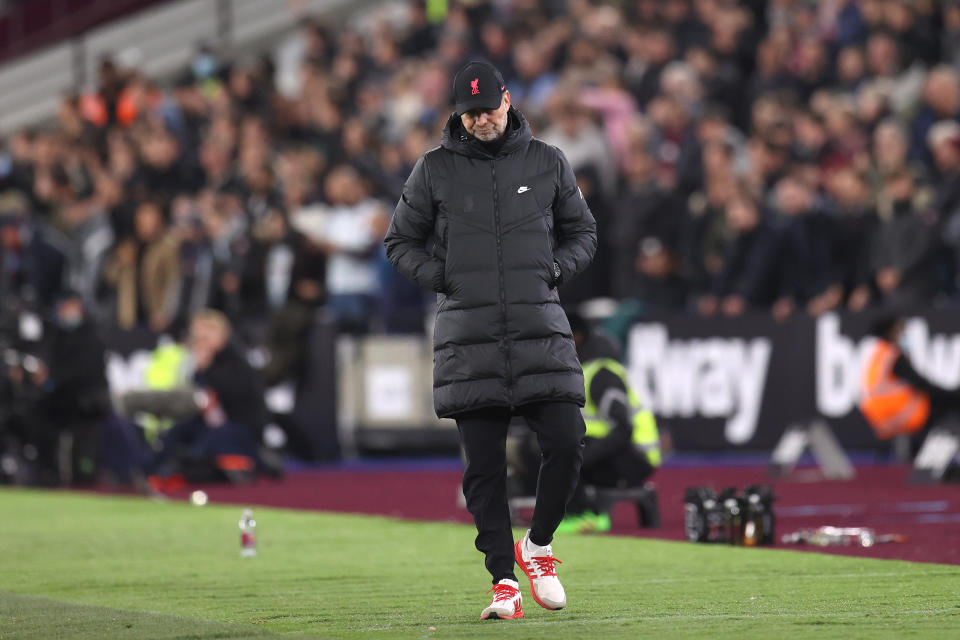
[0,0,960,480]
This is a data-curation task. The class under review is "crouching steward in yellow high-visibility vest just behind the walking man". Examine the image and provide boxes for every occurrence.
[520,314,660,533]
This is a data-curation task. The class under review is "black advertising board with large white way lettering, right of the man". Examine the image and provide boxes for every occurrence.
[626,310,960,451]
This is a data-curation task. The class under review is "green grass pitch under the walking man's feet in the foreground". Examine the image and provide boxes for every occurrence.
[0,489,960,640]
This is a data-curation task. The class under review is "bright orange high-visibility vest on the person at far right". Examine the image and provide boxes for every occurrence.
[860,340,930,440]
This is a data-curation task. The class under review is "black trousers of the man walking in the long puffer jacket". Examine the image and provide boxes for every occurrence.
[456,402,586,583]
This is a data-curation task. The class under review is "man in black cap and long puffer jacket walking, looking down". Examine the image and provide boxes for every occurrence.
[385,62,597,618]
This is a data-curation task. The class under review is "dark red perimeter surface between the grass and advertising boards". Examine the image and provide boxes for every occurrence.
[129,466,960,564]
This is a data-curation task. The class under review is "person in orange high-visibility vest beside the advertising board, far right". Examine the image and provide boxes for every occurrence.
[860,315,960,440]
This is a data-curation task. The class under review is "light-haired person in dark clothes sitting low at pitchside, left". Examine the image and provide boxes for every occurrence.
[150,310,267,488]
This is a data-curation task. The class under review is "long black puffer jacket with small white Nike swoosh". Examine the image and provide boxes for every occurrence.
[385,108,597,417]
